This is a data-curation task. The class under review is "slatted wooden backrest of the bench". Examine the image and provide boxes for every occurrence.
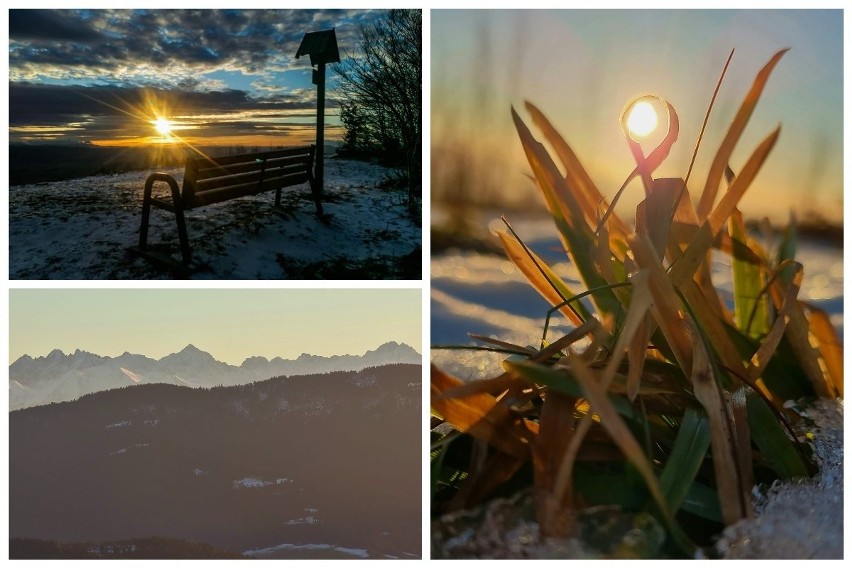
[181,146,314,208]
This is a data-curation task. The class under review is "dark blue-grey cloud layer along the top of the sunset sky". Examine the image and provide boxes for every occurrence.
[9,10,377,80]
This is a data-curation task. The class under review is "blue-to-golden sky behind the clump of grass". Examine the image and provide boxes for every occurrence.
[430,10,843,220]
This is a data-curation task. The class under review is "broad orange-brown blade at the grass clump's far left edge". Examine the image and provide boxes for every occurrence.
[431,365,533,459]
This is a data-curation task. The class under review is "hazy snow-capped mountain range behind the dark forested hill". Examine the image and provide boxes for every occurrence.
[9,341,422,410]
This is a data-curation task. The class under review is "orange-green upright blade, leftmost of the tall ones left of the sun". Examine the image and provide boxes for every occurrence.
[512,108,621,314]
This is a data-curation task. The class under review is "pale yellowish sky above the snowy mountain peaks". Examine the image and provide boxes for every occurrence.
[9,289,422,365]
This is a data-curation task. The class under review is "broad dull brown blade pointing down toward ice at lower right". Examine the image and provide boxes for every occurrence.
[691,324,750,525]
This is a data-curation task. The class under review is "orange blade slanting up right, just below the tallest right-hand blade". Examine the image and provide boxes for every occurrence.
[671,127,781,287]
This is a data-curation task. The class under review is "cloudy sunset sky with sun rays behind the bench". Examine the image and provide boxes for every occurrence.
[9,10,380,145]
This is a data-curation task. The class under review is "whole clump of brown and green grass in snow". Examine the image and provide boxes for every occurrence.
[431,50,843,556]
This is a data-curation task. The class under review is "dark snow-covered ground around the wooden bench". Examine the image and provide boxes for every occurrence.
[9,159,421,280]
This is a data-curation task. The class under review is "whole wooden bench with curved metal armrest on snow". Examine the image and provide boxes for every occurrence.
[134,146,323,265]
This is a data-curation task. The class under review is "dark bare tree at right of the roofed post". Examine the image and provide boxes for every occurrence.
[333,10,423,205]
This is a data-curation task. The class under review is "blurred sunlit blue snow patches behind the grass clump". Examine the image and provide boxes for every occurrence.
[430,211,843,379]
